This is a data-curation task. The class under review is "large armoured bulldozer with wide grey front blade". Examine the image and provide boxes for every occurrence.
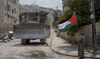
[13,12,50,44]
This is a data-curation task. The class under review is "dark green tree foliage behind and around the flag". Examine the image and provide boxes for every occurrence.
[56,0,100,35]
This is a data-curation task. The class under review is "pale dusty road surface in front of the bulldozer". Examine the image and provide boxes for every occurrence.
[0,40,53,59]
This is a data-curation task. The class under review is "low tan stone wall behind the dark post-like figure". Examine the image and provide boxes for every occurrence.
[56,23,100,47]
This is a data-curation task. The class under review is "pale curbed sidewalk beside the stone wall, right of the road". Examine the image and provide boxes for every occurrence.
[52,30,100,59]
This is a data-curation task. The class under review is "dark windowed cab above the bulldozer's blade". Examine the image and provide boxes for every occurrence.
[20,11,48,24]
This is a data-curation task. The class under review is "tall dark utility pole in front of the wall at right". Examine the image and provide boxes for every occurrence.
[90,0,97,52]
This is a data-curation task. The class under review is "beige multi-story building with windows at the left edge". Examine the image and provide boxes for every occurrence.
[0,0,19,33]
